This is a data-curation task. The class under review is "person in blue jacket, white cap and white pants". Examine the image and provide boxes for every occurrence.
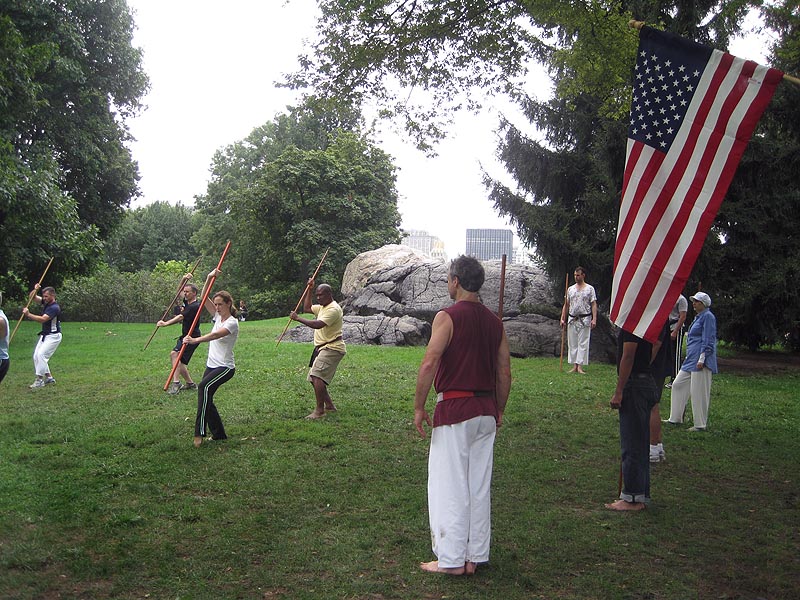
[667,292,718,431]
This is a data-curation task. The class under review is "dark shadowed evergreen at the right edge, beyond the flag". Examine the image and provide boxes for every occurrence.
[708,2,800,350]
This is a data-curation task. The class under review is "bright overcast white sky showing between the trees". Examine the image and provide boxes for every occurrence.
[128,0,772,257]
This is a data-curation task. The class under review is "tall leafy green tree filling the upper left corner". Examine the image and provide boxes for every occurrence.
[0,0,147,294]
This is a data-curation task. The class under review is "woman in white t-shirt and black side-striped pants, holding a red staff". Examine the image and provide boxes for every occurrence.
[184,269,239,447]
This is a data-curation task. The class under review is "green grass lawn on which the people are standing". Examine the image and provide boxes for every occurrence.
[0,319,800,600]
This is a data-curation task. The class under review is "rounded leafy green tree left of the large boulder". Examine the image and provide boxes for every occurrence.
[194,98,400,316]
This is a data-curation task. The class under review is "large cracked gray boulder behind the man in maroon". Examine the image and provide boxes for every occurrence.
[287,245,615,362]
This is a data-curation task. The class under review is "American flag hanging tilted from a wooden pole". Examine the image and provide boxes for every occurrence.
[611,26,783,342]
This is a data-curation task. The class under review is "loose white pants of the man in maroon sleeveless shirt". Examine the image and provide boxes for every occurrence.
[428,416,497,568]
